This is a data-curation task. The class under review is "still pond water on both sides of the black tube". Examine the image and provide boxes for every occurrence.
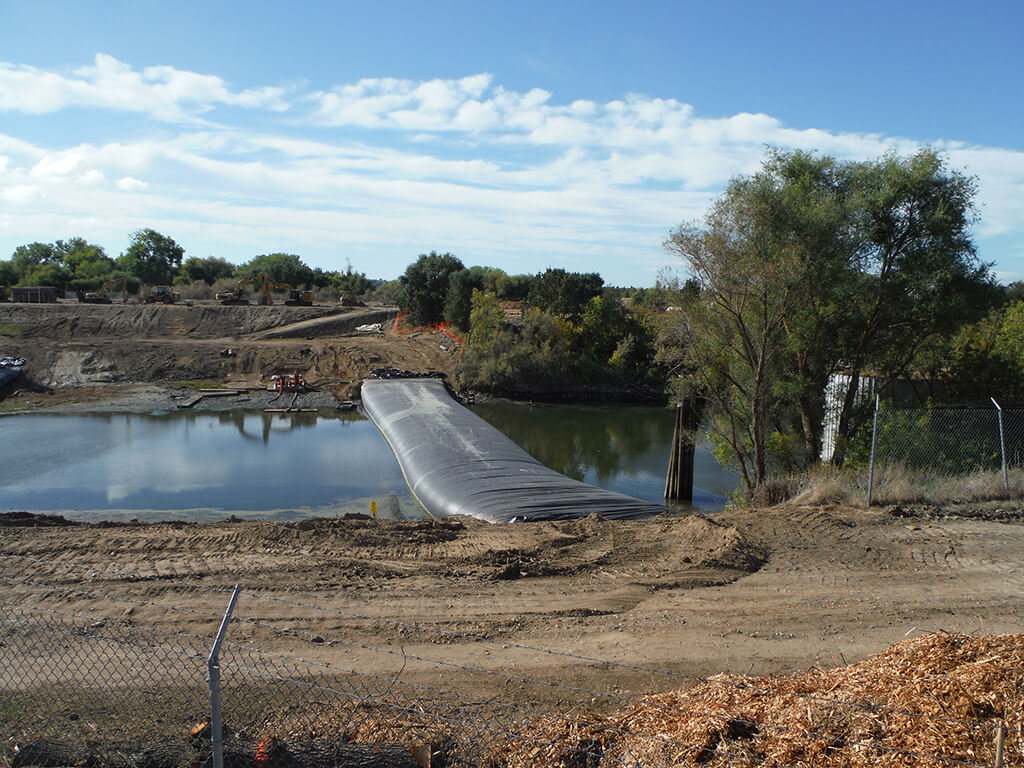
[0,403,735,521]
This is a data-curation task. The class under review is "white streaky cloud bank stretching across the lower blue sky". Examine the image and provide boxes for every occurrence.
[0,54,1024,285]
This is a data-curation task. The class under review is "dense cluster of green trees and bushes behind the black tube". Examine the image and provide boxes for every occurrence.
[397,251,662,396]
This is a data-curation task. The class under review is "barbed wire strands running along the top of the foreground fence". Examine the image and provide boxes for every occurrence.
[0,554,998,730]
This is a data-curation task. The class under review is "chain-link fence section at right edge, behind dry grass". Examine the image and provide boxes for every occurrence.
[867,400,1024,505]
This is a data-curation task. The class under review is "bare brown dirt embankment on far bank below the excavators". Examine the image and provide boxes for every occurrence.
[0,303,458,411]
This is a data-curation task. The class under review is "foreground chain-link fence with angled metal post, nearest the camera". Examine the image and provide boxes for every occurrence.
[0,556,1024,768]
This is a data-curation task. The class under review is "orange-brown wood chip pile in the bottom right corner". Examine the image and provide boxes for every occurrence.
[496,633,1024,768]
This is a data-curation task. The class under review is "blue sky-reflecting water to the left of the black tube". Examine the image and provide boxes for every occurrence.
[0,409,420,519]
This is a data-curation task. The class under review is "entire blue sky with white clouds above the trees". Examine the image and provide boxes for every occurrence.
[0,0,1024,287]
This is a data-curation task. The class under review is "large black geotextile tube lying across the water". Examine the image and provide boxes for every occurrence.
[362,379,667,522]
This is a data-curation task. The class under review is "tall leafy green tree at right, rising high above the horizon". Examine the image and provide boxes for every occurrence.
[666,150,991,490]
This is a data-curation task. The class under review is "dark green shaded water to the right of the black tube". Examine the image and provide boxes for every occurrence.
[473,401,736,507]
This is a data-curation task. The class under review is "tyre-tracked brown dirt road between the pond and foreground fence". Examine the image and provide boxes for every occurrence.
[0,507,1024,706]
